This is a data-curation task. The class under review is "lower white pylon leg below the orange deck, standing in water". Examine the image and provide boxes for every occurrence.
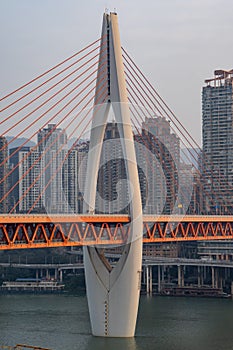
[84,240,142,337]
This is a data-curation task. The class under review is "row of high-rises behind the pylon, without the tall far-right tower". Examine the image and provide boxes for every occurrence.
[0,116,202,214]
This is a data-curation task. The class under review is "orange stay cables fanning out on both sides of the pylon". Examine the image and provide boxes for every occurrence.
[0,37,229,214]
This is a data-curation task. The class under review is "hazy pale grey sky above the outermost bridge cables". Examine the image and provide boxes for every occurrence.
[0,0,233,143]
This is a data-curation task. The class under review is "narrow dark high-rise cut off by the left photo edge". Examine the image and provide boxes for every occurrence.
[0,136,8,214]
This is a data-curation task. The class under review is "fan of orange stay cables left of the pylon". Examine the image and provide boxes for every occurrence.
[0,38,108,214]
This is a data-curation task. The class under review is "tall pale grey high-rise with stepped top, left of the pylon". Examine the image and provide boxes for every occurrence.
[37,124,69,213]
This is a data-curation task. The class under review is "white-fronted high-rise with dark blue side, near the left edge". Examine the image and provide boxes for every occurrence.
[9,147,42,213]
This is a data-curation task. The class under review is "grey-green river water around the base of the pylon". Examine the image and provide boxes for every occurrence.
[0,294,233,350]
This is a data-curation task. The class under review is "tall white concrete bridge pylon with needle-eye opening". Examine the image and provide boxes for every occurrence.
[84,13,143,337]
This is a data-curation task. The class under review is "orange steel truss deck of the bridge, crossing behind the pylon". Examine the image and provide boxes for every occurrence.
[0,214,233,250]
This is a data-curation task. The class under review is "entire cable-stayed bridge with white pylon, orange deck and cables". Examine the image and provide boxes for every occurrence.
[0,13,233,337]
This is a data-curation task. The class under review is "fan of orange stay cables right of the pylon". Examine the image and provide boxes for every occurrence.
[122,48,232,214]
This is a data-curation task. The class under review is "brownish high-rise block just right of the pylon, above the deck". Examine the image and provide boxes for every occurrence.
[135,116,180,214]
